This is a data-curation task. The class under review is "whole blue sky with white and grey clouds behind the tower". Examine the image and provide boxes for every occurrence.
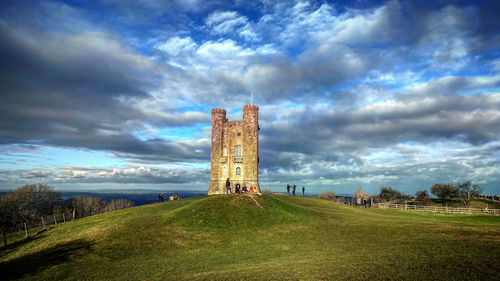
[0,0,500,194]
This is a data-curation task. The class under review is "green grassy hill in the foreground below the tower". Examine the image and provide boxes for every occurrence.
[0,195,500,280]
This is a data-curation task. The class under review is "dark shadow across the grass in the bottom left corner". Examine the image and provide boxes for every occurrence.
[0,239,92,280]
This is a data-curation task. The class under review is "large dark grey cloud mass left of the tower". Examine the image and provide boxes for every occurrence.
[0,4,209,161]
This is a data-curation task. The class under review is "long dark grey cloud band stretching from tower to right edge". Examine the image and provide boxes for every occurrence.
[261,90,500,155]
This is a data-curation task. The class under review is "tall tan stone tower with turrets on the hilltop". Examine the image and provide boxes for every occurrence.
[208,105,260,195]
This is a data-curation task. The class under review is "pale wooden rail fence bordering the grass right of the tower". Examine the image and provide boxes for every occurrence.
[373,203,500,215]
